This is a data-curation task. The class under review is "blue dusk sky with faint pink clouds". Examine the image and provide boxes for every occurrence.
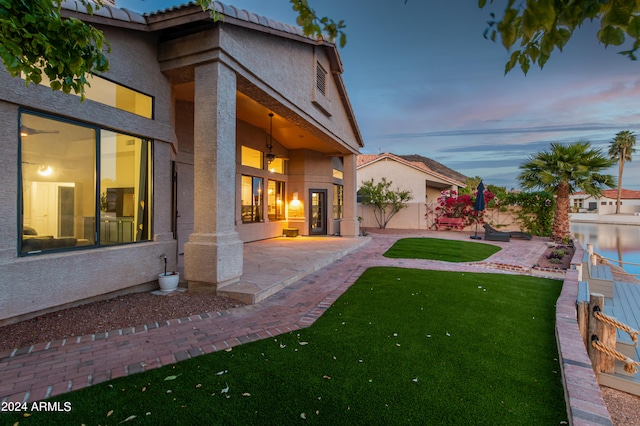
[117,0,640,190]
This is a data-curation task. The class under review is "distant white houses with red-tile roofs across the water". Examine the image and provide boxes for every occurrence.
[569,188,640,215]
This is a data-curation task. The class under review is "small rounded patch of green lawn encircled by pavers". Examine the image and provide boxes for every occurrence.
[384,238,501,262]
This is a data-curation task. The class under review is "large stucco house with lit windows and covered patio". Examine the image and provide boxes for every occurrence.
[0,1,363,323]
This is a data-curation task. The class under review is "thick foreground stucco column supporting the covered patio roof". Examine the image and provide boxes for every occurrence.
[184,62,242,291]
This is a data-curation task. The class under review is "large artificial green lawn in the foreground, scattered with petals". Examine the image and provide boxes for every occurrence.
[11,268,566,425]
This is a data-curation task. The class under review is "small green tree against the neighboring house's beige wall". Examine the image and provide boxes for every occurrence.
[358,177,413,229]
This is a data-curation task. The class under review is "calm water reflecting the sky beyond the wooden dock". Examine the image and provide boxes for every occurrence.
[571,223,640,278]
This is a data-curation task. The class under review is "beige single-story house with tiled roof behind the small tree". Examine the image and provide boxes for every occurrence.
[357,153,467,229]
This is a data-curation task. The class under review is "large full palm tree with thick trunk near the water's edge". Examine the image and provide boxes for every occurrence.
[518,141,615,241]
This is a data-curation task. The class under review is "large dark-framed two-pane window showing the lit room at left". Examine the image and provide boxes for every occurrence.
[20,112,151,254]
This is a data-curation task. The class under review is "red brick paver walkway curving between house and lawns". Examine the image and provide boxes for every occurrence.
[0,232,606,424]
